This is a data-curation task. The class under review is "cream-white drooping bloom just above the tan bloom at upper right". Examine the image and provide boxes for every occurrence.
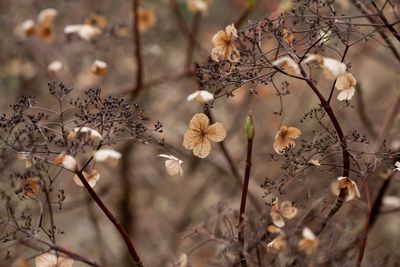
[304,54,346,80]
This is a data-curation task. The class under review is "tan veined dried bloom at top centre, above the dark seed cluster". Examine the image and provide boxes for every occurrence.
[211,24,240,62]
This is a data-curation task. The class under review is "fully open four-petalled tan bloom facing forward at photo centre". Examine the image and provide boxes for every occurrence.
[183,113,226,158]
